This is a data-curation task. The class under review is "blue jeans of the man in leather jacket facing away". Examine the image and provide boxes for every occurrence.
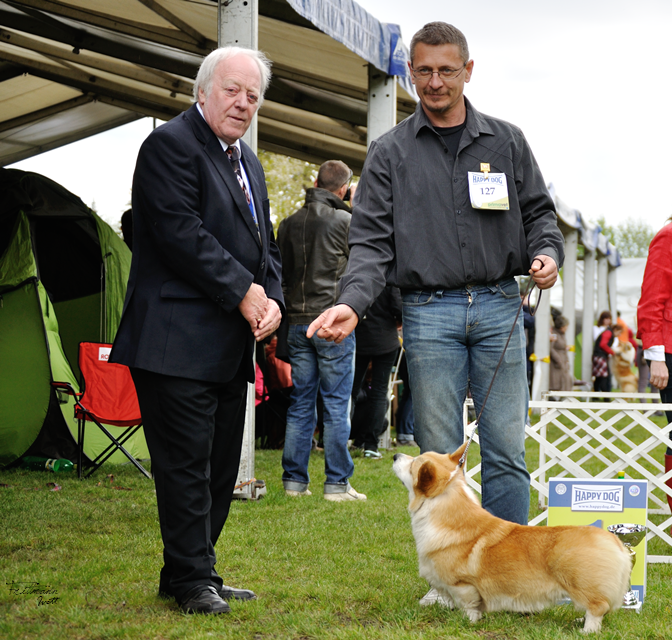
[282,324,355,493]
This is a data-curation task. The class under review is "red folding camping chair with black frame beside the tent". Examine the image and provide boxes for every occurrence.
[51,342,152,478]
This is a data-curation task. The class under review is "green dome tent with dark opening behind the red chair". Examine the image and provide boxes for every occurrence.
[0,169,149,467]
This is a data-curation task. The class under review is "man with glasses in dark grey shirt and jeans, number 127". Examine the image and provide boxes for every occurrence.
[308,22,564,548]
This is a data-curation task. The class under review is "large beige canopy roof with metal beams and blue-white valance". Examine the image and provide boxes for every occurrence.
[0,0,415,170]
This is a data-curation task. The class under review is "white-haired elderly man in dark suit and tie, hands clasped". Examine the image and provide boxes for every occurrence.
[110,47,284,613]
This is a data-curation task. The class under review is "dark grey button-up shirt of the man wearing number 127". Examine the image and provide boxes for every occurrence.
[339,98,564,318]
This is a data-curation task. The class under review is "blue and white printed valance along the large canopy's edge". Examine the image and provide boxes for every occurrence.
[287,0,415,96]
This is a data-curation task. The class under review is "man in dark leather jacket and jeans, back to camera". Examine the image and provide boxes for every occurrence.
[278,160,366,502]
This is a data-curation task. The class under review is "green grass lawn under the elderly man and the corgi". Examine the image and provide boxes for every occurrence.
[0,447,672,640]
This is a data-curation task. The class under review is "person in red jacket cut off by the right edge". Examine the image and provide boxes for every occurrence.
[637,223,672,524]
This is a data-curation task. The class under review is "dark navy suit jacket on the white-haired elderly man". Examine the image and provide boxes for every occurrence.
[110,105,284,382]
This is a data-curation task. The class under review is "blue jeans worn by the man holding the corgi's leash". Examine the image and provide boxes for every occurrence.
[403,279,530,524]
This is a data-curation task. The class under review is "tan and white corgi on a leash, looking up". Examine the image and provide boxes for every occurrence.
[392,443,631,633]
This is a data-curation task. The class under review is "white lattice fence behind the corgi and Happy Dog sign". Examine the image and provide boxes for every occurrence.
[464,392,672,562]
